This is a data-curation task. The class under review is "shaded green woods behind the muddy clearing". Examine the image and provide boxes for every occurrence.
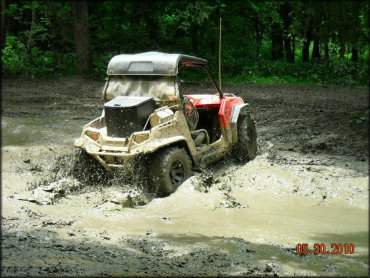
[1,0,369,86]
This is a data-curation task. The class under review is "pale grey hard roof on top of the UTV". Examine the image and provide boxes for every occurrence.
[107,51,207,76]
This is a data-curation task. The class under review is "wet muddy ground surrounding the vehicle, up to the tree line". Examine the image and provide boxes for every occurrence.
[1,77,369,277]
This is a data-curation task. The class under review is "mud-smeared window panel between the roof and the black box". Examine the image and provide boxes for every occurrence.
[103,75,179,102]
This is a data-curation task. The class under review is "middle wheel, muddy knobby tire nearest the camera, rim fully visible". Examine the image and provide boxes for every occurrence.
[149,147,192,196]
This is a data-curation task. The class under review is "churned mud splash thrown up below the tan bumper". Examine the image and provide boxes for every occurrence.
[14,150,157,208]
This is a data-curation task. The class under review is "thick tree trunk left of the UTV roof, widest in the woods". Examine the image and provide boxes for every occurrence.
[72,0,93,73]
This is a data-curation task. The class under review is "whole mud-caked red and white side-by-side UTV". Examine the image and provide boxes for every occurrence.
[74,52,257,195]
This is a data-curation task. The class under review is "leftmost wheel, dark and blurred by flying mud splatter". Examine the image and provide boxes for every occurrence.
[72,149,109,183]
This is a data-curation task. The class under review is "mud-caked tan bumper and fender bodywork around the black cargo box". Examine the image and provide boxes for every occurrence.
[75,106,194,170]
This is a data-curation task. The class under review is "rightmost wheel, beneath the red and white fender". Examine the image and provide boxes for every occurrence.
[234,113,257,161]
